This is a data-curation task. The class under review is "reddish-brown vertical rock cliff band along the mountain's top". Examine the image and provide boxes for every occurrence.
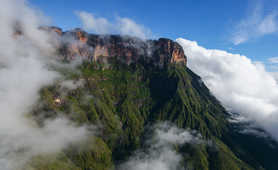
[40,27,187,67]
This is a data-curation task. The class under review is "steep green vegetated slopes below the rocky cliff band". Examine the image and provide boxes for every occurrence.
[27,61,277,170]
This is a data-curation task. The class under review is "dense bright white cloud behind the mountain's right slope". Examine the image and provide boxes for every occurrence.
[177,38,278,140]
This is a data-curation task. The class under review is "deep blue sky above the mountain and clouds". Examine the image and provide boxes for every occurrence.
[29,0,278,70]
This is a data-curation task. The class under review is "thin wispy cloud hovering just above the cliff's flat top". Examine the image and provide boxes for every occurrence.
[76,11,151,39]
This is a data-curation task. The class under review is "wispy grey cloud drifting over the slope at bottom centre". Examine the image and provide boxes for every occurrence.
[119,123,203,170]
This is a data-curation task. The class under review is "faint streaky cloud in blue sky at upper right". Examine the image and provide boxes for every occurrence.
[231,3,278,45]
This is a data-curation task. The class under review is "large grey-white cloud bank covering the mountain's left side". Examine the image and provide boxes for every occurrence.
[0,0,87,170]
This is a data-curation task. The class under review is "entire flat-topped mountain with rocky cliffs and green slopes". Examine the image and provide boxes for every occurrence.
[17,27,278,170]
